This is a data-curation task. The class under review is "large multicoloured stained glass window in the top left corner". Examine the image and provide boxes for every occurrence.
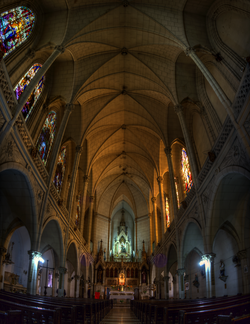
[0,7,35,57]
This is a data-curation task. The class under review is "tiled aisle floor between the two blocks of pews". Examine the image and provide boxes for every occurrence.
[101,307,140,324]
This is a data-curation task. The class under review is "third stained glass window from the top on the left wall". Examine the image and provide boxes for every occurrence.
[37,111,56,165]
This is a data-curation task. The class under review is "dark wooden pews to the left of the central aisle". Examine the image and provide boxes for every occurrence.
[0,290,113,324]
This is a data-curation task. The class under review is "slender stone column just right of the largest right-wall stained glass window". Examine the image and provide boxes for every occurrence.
[174,105,199,189]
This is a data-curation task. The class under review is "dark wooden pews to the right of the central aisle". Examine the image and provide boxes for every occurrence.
[130,295,250,324]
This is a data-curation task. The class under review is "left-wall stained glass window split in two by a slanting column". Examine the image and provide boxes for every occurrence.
[14,63,45,120]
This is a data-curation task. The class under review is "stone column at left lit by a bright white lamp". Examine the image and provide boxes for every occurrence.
[27,250,42,295]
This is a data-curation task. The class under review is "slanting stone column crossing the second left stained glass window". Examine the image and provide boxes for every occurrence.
[0,46,65,145]
